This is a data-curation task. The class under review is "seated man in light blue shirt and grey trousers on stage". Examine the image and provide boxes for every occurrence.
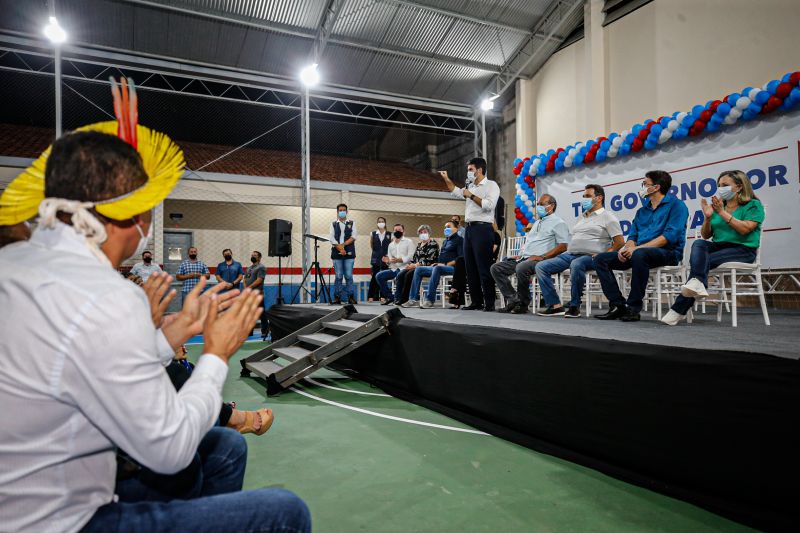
[490,194,569,314]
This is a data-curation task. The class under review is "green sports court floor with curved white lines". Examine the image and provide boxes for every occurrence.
[190,342,748,533]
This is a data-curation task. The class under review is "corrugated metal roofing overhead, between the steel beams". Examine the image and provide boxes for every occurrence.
[0,0,582,104]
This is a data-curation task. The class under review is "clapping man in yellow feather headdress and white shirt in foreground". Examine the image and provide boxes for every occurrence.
[0,129,309,531]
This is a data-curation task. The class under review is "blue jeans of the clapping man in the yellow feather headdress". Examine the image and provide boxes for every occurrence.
[83,427,311,532]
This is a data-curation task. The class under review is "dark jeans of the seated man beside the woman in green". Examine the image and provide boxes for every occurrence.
[592,248,678,313]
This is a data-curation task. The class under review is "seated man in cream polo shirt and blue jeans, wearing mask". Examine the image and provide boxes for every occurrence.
[536,185,625,318]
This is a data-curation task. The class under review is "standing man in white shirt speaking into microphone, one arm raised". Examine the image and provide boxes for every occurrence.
[439,157,500,311]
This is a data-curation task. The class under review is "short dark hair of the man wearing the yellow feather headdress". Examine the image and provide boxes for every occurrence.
[44,131,147,202]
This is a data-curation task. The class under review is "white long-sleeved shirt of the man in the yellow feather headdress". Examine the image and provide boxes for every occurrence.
[0,222,227,532]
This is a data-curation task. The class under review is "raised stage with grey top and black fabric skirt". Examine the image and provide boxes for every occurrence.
[269,304,800,530]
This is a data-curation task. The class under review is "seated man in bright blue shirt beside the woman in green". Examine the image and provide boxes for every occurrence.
[593,170,689,322]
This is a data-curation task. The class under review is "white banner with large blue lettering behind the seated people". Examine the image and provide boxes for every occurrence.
[536,111,800,268]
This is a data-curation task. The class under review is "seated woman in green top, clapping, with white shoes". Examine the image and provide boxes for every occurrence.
[661,170,764,326]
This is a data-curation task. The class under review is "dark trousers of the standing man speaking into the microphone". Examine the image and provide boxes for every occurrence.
[464,224,495,307]
